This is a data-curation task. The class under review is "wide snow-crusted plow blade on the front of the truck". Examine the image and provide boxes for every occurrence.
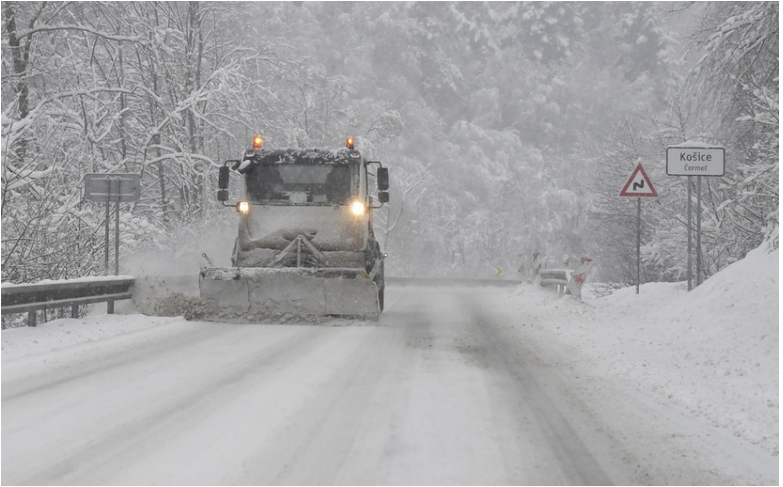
[199,267,380,320]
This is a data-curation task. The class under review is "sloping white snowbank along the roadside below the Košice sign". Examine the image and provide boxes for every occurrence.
[511,246,780,456]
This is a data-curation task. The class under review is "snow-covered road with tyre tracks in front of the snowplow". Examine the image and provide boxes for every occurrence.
[2,287,776,485]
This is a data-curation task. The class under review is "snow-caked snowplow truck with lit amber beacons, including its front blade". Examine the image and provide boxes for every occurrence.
[199,136,389,320]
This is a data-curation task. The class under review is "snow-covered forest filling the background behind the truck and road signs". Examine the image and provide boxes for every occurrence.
[0,1,780,286]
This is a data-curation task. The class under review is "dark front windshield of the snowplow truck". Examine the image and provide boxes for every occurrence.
[245,164,353,204]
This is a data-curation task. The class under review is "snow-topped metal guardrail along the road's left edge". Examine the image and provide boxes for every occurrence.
[0,277,135,326]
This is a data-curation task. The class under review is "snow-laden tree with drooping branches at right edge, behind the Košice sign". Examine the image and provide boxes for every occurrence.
[693,2,780,255]
